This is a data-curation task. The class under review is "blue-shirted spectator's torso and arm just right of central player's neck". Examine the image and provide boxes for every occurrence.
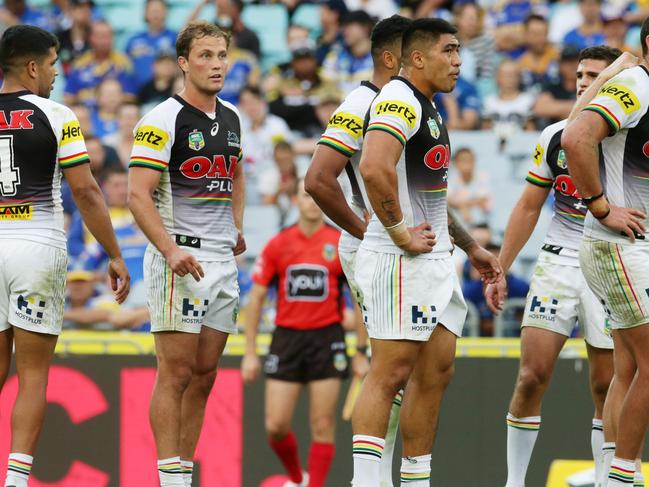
[433,78,481,130]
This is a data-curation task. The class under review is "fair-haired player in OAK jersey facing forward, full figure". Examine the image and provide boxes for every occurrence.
[129,21,245,486]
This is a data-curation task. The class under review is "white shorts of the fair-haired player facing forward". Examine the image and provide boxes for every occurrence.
[144,247,239,333]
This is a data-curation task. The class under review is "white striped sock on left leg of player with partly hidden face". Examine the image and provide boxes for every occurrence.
[507,413,541,487]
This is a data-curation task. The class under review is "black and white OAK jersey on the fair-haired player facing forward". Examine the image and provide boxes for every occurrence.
[129,95,242,260]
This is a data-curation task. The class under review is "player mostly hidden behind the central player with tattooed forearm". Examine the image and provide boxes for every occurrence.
[304,15,411,487]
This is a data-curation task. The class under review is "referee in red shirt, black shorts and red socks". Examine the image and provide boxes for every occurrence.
[241,181,348,487]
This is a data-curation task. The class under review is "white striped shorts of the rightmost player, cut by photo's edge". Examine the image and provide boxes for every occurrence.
[579,238,649,329]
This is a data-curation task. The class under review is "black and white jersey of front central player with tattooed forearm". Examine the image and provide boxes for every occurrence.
[361,76,451,258]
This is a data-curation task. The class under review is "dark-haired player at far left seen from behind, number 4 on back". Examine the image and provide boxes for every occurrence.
[0,25,129,487]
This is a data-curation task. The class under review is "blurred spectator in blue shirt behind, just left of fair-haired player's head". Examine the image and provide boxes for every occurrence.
[126,0,177,88]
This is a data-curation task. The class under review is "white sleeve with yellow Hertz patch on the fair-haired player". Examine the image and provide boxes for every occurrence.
[129,109,173,172]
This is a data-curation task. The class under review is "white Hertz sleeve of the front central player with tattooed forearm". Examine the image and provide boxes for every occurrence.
[367,82,421,146]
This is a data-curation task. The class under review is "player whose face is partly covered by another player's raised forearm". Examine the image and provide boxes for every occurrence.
[485,46,634,487]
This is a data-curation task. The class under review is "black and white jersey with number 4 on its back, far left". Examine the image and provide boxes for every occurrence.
[0,91,90,249]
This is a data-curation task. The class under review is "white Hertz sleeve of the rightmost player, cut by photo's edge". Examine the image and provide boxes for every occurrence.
[584,67,649,135]
